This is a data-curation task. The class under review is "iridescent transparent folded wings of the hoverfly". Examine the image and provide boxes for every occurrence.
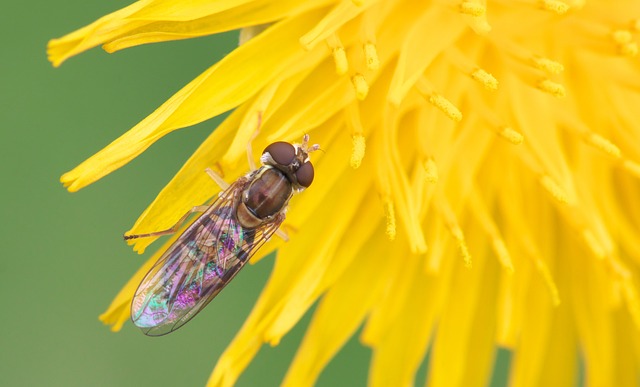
[131,178,284,336]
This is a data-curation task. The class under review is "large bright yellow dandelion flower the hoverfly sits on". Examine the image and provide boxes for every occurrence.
[48,0,640,386]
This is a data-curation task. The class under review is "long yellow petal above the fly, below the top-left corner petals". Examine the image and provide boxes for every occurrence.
[61,11,332,191]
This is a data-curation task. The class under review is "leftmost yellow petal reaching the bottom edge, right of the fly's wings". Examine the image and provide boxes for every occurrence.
[209,157,372,385]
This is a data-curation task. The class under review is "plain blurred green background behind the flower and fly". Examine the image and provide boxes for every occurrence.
[0,0,509,386]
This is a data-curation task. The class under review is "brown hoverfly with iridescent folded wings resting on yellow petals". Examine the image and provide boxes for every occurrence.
[125,135,319,336]
